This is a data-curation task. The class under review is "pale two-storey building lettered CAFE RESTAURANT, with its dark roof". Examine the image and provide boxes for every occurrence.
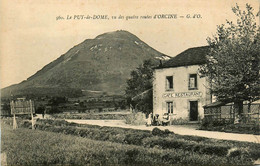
[153,47,212,121]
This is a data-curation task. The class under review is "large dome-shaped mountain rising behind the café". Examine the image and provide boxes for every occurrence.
[2,30,169,97]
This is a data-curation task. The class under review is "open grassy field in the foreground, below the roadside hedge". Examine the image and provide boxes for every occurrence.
[1,122,252,166]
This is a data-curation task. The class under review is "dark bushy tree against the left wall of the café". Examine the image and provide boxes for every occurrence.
[125,60,154,114]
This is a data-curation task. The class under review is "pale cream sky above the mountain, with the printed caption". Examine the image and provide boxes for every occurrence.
[0,0,260,88]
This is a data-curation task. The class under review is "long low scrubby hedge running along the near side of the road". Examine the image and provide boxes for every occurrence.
[15,120,260,159]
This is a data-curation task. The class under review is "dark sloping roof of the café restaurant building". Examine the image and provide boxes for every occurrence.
[155,46,209,69]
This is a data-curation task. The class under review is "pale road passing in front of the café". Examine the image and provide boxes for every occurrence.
[66,119,260,143]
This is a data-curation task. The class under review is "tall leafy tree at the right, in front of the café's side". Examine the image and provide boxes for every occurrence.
[199,4,260,114]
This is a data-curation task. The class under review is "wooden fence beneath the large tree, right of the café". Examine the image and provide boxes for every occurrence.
[204,104,260,123]
